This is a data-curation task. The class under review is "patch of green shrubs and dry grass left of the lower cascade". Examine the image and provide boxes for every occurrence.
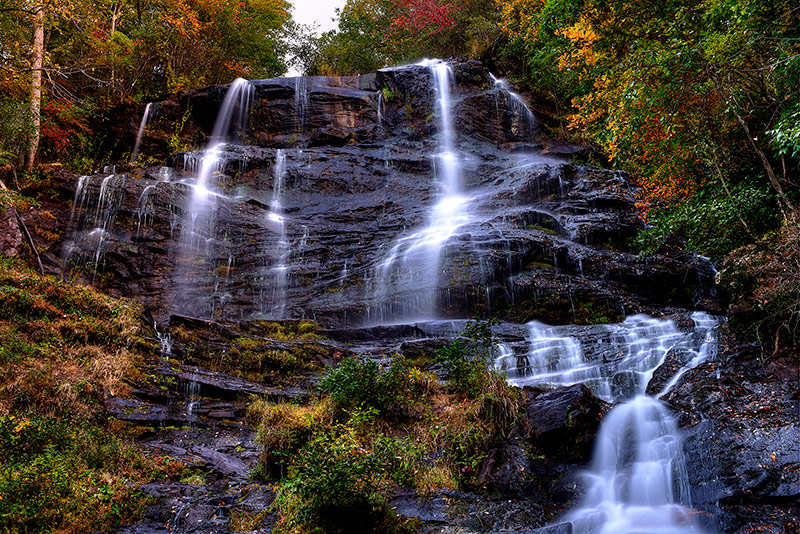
[250,323,518,533]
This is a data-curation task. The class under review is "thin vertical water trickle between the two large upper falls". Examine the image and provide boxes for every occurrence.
[261,149,291,319]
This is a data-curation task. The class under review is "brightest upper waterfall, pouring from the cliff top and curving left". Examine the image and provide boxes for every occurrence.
[367,60,469,323]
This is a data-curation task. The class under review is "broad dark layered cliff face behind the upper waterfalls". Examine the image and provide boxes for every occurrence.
[40,62,713,327]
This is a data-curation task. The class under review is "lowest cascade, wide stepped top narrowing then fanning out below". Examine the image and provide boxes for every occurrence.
[496,312,718,534]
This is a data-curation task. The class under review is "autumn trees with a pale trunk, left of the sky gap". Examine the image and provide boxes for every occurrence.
[0,0,291,169]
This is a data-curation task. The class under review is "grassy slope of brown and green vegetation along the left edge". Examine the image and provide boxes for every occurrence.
[0,256,183,533]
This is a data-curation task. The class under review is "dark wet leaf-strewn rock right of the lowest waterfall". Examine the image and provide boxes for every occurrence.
[665,350,800,533]
